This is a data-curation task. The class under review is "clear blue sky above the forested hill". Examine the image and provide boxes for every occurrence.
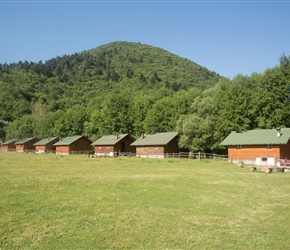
[0,0,290,79]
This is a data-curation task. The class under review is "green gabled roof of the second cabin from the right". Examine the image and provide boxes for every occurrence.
[131,132,179,146]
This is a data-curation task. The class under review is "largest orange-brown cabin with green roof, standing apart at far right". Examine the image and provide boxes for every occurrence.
[220,128,290,165]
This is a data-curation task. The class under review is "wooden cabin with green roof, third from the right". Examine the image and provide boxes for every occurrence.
[92,134,136,156]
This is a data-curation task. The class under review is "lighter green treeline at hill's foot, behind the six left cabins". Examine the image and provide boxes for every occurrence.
[0,88,202,143]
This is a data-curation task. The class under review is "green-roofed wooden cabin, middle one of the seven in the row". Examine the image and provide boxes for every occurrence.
[53,135,92,154]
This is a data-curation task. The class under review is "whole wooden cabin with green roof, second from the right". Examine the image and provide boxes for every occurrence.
[131,132,180,158]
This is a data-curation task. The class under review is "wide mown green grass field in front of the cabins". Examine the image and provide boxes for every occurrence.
[0,153,290,249]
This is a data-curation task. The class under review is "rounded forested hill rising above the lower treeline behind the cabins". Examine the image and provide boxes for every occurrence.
[0,42,221,141]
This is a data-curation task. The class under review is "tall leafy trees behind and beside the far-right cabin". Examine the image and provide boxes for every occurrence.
[177,55,290,151]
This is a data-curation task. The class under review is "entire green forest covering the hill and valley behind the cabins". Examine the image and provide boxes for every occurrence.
[0,42,290,152]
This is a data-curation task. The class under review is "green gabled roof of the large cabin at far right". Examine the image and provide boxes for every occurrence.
[220,128,290,146]
